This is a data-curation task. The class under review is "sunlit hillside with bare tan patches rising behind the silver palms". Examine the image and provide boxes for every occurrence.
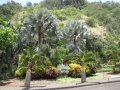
[11,2,120,42]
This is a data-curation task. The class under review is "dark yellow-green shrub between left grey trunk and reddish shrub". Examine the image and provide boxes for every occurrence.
[31,65,45,79]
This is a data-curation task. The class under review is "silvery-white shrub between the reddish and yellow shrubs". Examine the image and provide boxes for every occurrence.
[57,64,69,75]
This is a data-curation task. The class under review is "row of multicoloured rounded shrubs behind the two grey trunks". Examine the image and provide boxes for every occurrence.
[15,63,96,79]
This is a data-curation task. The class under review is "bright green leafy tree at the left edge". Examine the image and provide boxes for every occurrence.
[0,27,16,76]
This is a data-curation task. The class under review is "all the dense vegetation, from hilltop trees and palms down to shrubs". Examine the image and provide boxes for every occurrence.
[0,0,120,79]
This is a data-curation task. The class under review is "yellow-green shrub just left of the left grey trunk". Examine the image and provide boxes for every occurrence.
[15,66,28,78]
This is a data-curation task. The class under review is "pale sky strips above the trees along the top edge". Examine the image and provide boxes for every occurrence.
[0,0,120,6]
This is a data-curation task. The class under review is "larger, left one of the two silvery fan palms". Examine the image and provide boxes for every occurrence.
[21,8,58,52]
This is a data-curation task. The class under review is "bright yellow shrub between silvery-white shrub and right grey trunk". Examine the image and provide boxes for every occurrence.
[68,63,82,78]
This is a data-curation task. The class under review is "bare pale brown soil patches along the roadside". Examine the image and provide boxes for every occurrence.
[0,71,120,86]
